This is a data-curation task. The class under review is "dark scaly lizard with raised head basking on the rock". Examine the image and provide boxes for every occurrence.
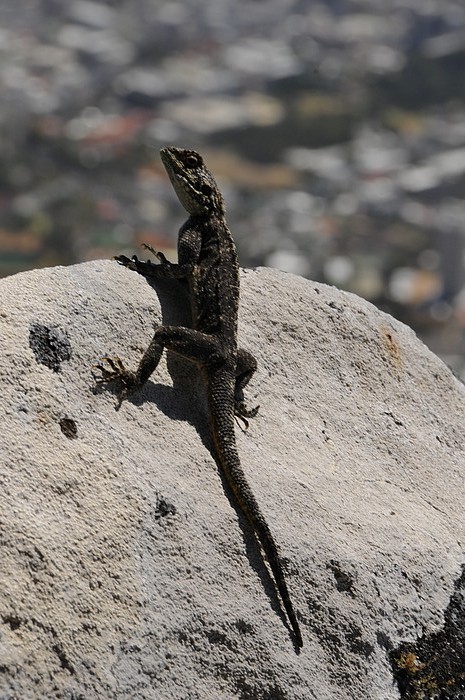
[95,146,303,648]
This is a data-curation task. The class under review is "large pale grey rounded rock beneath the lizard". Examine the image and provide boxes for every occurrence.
[0,261,465,700]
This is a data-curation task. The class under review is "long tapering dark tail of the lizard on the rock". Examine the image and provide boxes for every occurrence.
[208,376,303,647]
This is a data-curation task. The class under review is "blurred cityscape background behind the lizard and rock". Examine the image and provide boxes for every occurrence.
[0,0,465,378]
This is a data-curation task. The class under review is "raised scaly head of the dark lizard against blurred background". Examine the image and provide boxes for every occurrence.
[160,146,224,215]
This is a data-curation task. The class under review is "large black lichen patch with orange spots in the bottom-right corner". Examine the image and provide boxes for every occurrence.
[390,566,465,700]
